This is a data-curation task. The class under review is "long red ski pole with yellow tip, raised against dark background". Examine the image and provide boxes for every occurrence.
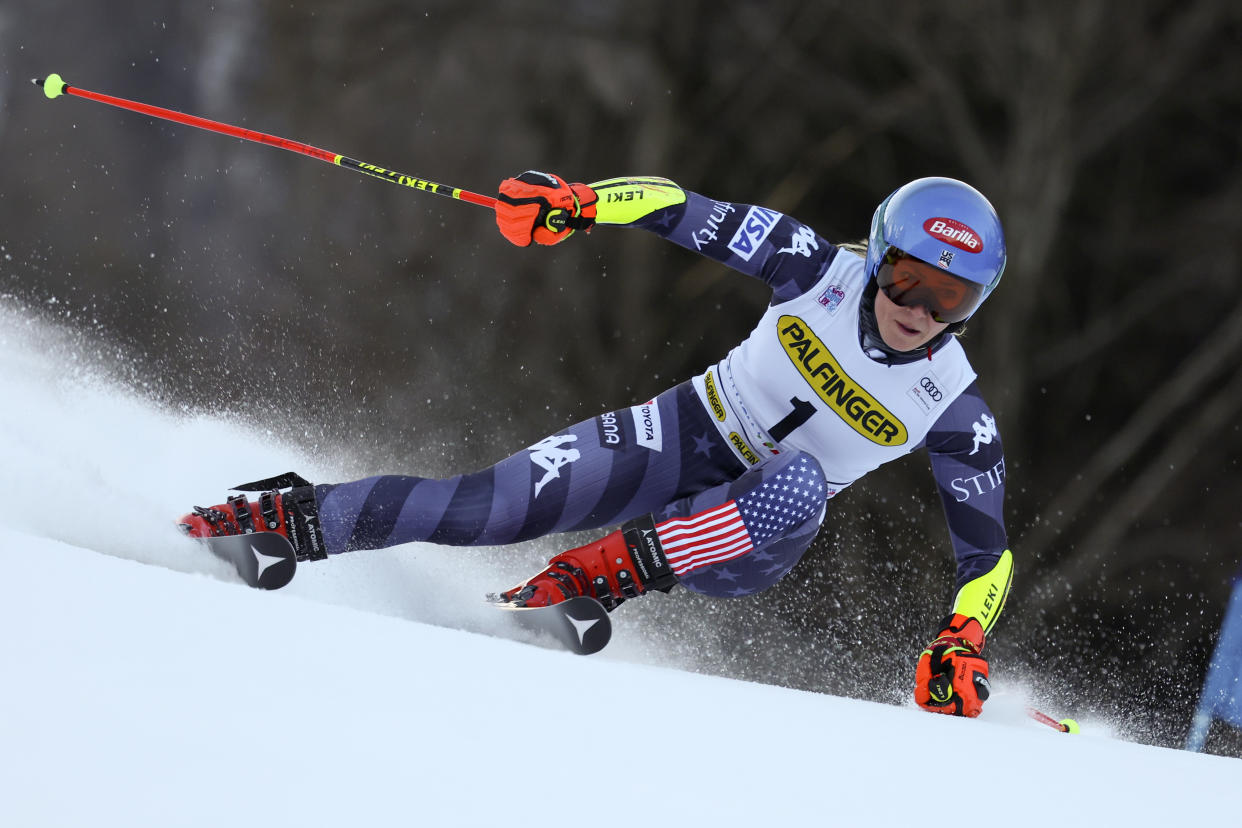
[31,74,496,207]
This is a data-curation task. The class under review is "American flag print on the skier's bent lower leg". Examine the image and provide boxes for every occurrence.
[656,458,825,577]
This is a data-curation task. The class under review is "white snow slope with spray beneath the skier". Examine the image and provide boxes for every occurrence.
[0,307,1242,828]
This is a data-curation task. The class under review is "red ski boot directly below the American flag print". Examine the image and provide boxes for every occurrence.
[492,516,677,611]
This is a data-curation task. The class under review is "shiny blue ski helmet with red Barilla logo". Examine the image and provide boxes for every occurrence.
[864,178,1006,322]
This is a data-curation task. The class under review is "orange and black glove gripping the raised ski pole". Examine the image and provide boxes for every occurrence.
[496,170,599,247]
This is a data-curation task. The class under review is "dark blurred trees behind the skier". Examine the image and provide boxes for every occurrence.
[0,0,1242,749]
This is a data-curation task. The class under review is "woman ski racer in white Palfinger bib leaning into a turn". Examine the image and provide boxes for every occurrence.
[180,171,1012,716]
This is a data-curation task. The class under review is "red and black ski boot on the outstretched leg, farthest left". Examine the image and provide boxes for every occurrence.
[178,472,328,561]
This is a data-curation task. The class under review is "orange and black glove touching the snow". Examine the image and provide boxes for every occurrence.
[914,613,991,718]
